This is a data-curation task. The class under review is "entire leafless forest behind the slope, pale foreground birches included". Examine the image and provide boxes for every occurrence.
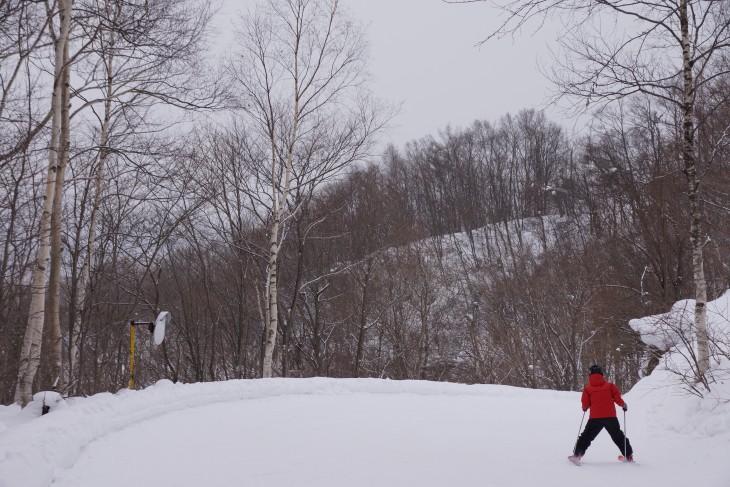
[0,0,730,404]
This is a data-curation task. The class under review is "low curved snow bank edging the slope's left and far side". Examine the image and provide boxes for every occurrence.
[0,379,556,487]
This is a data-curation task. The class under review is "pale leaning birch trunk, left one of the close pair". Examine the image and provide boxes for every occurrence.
[15,0,71,406]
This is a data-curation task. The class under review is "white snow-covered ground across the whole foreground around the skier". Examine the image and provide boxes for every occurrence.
[0,371,730,487]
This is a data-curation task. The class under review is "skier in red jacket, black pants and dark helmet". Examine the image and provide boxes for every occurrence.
[571,365,634,463]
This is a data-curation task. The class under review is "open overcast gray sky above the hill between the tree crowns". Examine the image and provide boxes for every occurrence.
[217,0,555,146]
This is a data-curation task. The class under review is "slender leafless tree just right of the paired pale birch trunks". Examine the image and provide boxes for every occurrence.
[67,0,218,396]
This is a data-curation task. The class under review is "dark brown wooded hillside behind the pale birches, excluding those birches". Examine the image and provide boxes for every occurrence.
[3,97,730,402]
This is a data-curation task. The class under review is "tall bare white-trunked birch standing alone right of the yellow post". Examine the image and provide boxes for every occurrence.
[231,0,387,377]
